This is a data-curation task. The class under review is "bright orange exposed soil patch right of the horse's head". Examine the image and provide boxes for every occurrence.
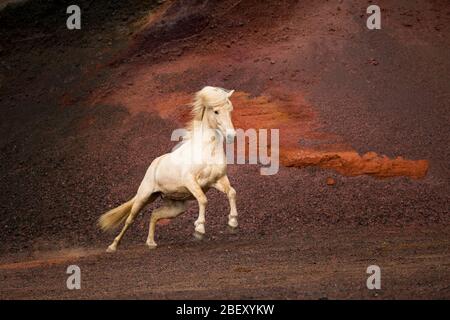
[235,94,428,178]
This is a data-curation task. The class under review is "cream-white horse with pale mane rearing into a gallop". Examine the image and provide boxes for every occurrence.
[99,87,238,252]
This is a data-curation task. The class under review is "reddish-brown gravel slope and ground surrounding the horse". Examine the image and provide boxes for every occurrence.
[0,0,450,299]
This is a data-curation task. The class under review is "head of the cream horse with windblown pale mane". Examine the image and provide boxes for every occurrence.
[196,87,236,143]
